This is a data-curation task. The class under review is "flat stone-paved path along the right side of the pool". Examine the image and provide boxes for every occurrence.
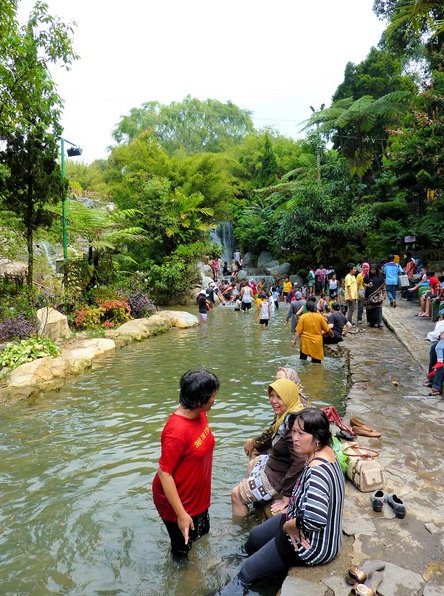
[281,302,444,596]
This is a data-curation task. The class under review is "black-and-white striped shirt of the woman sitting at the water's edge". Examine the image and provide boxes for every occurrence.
[287,458,344,565]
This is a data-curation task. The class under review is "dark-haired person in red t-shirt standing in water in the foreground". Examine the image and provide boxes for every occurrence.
[153,370,219,555]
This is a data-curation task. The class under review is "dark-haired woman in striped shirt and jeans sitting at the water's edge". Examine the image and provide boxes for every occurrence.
[221,408,344,594]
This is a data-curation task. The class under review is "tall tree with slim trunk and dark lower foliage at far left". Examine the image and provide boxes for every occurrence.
[0,0,76,295]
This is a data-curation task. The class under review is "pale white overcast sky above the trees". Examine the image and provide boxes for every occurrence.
[20,0,384,163]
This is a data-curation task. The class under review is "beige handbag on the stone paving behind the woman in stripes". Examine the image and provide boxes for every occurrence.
[343,443,385,493]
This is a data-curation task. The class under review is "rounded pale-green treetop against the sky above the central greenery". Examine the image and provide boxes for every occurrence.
[113,95,254,155]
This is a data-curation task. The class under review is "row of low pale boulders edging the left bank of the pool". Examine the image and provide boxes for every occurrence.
[0,310,199,405]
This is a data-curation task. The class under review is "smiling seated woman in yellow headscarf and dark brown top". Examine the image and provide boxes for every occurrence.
[231,379,305,517]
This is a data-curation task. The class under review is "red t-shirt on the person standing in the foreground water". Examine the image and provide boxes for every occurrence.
[153,412,215,522]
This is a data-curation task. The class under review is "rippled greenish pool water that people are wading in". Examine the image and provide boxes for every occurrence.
[0,306,345,596]
